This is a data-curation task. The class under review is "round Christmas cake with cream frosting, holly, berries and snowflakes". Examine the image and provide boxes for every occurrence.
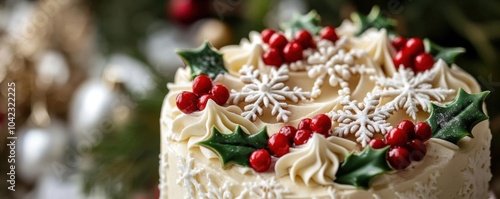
[159,10,491,199]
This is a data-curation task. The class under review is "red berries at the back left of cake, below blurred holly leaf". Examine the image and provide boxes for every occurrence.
[261,26,338,67]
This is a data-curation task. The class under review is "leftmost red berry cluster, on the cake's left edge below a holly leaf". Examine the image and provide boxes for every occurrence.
[176,75,229,114]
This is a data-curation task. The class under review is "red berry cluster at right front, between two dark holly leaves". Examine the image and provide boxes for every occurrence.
[370,120,432,170]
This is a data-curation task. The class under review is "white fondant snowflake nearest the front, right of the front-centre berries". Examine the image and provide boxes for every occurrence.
[328,93,394,147]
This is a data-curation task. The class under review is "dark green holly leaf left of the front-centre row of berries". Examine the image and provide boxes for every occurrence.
[198,126,269,167]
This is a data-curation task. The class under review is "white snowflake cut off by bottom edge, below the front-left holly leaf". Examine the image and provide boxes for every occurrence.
[237,177,288,199]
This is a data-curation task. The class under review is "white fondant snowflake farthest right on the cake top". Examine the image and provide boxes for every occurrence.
[370,67,454,119]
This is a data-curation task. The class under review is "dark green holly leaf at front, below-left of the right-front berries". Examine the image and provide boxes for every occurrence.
[335,147,392,189]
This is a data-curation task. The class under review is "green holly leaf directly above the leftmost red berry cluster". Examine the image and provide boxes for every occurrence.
[176,41,227,80]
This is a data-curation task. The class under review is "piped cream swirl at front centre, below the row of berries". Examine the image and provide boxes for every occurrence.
[274,133,356,186]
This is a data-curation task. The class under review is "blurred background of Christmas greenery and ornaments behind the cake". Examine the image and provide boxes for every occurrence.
[0,0,500,199]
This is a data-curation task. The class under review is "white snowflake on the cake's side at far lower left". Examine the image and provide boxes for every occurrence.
[177,154,203,199]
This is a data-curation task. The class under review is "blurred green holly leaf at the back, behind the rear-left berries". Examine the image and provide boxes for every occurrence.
[281,10,321,35]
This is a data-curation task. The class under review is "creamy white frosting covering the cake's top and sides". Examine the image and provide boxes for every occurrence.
[159,25,491,199]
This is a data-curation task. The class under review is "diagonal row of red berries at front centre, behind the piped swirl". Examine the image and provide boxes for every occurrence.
[250,114,332,172]
